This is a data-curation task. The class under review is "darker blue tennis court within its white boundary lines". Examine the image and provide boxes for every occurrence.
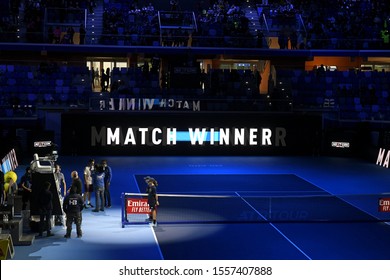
[129,174,390,259]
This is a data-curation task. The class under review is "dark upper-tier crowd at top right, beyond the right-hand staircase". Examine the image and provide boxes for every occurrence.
[268,0,390,49]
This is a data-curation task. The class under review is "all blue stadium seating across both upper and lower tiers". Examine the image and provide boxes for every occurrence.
[0,0,390,120]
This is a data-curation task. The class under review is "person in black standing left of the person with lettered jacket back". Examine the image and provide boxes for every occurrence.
[39,182,54,237]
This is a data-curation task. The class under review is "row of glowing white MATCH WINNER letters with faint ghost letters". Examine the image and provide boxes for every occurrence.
[91,126,287,146]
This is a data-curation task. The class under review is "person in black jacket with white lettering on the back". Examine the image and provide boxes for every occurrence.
[62,185,84,238]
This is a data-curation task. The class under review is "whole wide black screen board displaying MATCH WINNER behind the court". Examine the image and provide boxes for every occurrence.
[62,112,321,155]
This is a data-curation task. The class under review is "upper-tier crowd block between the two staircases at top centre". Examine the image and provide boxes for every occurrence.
[102,0,253,47]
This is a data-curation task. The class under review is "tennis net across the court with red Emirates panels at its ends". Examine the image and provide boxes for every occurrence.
[122,193,390,224]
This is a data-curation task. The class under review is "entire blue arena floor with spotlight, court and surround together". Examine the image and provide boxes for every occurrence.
[9,156,390,260]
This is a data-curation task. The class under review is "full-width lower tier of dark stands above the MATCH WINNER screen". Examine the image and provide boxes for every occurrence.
[0,56,390,120]
